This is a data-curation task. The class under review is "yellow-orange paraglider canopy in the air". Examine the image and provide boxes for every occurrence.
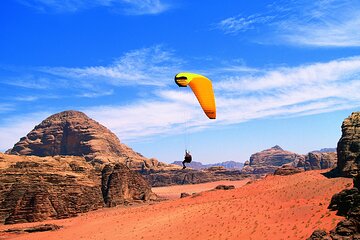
[175,72,216,119]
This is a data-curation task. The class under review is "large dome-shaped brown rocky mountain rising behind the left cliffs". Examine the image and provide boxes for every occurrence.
[9,111,177,170]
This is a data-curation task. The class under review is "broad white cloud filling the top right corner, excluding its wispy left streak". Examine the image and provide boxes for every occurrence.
[278,0,360,47]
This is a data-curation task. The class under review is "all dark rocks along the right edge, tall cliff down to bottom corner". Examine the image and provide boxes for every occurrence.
[309,112,360,240]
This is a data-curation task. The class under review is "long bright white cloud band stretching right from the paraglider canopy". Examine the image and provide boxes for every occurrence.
[216,57,360,91]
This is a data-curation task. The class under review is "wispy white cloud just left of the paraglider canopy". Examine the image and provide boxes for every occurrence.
[40,46,181,86]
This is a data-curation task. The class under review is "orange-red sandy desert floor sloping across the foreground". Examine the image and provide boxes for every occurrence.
[0,171,352,240]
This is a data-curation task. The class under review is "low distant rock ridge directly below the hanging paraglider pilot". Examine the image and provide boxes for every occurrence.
[142,167,249,187]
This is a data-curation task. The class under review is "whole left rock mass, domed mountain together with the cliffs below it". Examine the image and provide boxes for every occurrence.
[0,111,163,223]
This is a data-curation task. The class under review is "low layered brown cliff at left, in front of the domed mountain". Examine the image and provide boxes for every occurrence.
[0,154,154,224]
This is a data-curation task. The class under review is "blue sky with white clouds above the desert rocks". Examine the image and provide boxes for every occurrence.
[0,0,360,163]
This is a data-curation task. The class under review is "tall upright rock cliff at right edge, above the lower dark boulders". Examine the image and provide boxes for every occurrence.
[335,112,360,177]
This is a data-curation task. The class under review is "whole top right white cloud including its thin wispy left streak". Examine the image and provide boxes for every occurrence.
[217,0,360,47]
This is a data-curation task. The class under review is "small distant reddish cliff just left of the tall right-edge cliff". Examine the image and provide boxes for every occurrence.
[304,152,337,171]
